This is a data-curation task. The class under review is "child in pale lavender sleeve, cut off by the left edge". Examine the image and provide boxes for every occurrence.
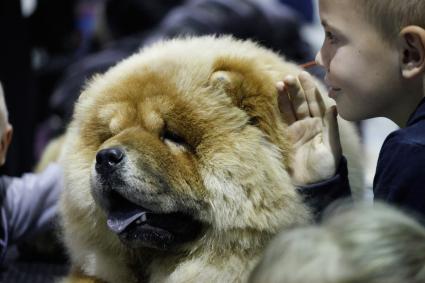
[0,84,62,265]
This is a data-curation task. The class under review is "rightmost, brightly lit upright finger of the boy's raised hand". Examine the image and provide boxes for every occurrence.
[299,71,326,117]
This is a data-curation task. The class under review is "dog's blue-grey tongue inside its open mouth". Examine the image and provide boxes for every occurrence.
[106,207,147,234]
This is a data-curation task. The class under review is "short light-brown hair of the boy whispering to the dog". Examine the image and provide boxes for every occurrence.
[356,0,425,44]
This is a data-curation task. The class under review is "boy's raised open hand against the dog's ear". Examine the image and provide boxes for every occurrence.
[276,72,342,186]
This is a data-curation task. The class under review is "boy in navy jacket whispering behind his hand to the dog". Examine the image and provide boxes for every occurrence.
[278,0,425,220]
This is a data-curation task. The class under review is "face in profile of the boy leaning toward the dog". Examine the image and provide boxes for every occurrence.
[316,0,402,121]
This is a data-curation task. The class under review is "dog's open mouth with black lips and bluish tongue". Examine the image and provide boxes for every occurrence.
[103,192,201,250]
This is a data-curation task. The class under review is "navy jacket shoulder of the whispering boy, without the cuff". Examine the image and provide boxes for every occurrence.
[373,99,425,221]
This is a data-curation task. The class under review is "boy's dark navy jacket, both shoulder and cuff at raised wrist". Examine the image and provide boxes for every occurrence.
[299,99,425,221]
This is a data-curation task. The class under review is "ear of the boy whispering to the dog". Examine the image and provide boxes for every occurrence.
[400,26,425,79]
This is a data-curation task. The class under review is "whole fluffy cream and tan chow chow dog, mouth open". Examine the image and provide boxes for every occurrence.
[61,36,360,283]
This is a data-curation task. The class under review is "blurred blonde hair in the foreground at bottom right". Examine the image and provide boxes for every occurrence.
[249,204,425,283]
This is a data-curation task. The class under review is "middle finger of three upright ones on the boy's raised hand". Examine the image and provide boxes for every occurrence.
[283,76,310,120]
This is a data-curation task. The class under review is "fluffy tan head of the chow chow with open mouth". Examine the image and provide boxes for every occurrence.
[64,37,307,255]
